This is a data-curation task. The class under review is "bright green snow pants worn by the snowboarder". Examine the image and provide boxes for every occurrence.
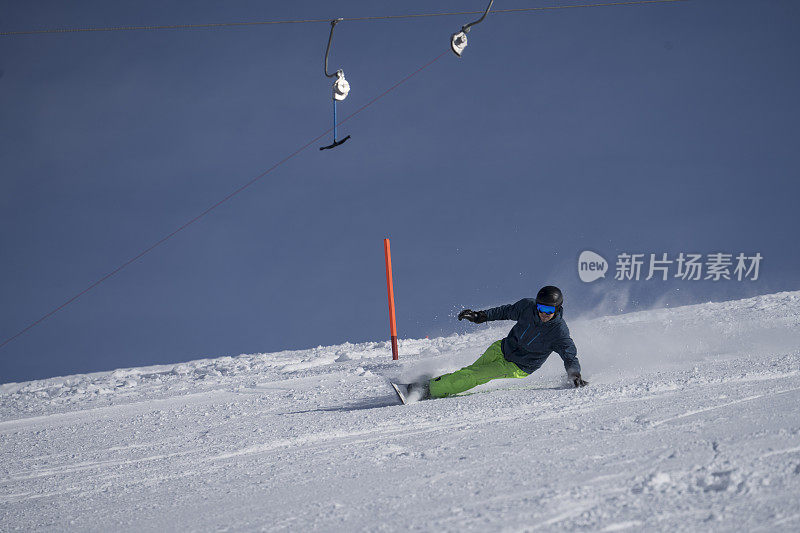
[430,341,528,398]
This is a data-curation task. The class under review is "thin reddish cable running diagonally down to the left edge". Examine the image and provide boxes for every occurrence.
[0,50,447,349]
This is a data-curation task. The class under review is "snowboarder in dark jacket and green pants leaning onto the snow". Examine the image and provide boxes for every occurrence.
[408,285,587,399]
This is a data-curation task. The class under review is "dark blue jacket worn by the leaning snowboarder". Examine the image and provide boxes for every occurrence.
[486,298,581,374]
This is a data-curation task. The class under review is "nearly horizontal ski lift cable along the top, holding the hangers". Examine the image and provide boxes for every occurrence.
[0,0,690,37]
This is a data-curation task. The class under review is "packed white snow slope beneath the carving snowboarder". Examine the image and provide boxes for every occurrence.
[0,292,800,532]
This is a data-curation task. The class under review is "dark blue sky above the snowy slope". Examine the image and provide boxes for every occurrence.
[0,0,800,382]
